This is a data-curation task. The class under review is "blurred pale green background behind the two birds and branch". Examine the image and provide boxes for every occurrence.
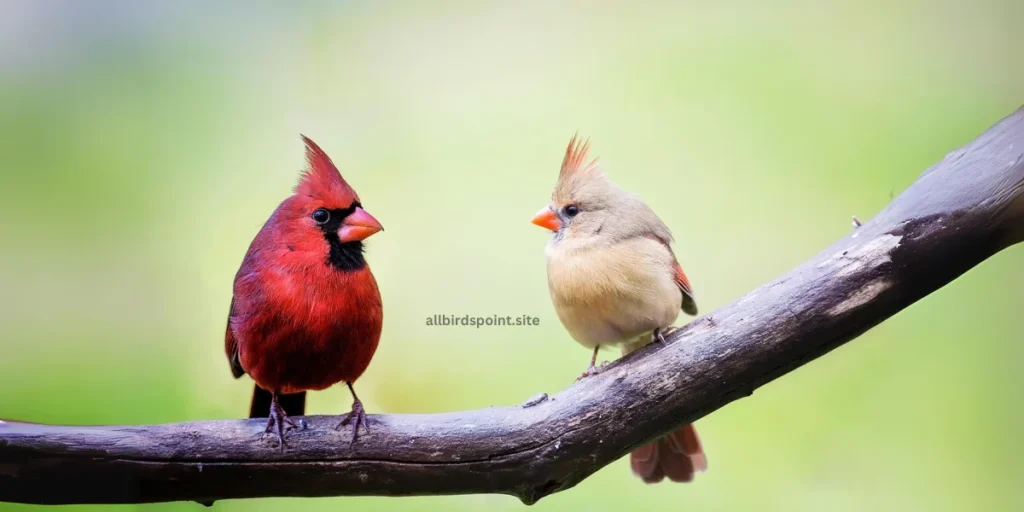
[0,0,1024,511]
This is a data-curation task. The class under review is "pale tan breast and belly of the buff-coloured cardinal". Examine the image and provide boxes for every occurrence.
[547,238,682,347]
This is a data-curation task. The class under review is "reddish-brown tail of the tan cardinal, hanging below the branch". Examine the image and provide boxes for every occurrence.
[630,425,708,483]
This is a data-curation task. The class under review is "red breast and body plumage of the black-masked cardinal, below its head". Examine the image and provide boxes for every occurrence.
[229,222,383,393]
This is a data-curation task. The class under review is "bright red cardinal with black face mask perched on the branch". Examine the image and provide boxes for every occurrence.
[224,136,383,449]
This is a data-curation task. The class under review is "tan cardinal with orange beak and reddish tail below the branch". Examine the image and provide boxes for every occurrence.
[532,136,708,483]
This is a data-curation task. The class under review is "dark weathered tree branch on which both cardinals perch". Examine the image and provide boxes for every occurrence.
[0,108,1024,504]
